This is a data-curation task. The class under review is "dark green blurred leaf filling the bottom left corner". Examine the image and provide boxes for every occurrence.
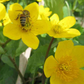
[0,65,17,84]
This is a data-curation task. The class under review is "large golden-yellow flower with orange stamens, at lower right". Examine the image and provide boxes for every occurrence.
[44,40,84,84]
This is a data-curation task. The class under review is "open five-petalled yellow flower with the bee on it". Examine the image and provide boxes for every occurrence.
[3,2,50,49]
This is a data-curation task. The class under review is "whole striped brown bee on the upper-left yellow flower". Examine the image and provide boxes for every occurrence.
[16,10,30,27]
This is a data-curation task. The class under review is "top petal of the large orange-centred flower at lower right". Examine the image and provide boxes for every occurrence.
[55,40,74,59]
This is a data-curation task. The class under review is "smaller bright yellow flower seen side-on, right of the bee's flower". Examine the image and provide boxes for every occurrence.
[48,14,80,38]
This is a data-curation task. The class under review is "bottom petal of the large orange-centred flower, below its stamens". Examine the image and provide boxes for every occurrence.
[50,69,84,84]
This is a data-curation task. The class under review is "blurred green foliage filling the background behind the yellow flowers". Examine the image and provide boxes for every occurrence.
[0,0,84,84]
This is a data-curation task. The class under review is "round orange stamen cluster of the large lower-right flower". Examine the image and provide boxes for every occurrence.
[56,56,79,82]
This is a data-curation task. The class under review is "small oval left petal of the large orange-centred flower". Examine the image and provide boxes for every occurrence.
[44,55,57,77]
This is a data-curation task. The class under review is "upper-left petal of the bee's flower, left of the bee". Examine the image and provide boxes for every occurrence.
[8,3,23,24]
